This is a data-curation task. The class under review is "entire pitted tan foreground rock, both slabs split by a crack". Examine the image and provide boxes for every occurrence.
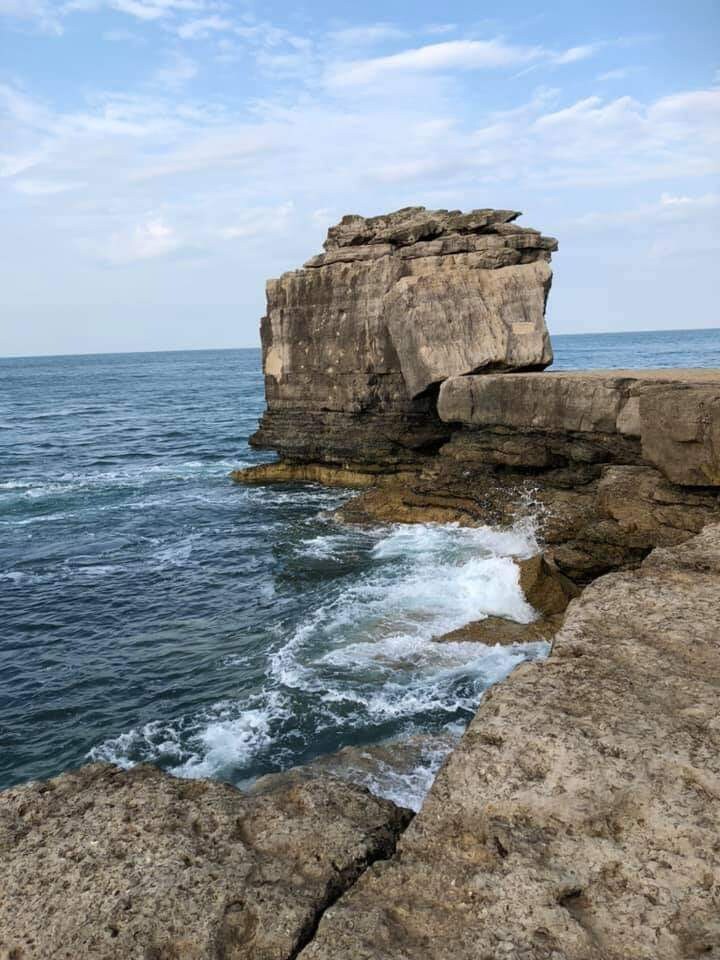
[0,524,720,960]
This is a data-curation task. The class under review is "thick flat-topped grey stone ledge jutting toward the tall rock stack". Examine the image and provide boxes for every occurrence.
[438,370,720,486]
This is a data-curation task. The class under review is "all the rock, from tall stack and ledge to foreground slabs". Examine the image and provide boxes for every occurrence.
[0,208,720,960]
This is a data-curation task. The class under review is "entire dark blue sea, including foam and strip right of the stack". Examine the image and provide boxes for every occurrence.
[0,330,720,809]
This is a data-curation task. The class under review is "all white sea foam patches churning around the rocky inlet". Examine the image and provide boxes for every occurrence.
[87,516,548,809]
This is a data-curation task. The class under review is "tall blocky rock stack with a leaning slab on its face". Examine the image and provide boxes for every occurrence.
[252,207,557,465]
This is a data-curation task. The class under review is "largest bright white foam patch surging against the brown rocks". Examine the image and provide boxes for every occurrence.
[271,524,536,691]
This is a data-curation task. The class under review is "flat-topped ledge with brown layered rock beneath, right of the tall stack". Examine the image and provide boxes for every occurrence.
[334,370,720,582]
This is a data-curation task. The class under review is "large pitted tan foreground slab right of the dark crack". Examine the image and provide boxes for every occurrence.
[301,525,720,960]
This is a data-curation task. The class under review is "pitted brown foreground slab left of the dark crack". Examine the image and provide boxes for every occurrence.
[0,764,409,960]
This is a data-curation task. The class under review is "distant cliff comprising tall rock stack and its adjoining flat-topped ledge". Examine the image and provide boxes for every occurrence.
[232,207,720,583]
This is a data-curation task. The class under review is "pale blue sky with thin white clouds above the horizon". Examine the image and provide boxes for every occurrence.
[0,0,720,356]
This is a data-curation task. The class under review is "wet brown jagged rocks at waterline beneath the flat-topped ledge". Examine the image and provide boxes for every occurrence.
[338,454,720,583]
